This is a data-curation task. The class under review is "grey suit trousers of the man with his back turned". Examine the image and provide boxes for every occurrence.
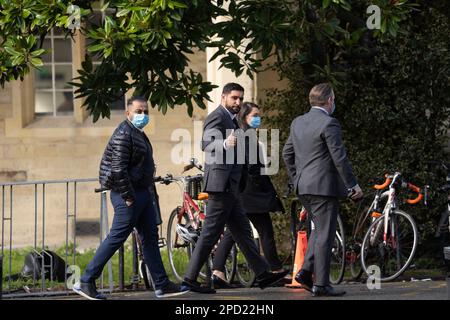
[299,195,339,286]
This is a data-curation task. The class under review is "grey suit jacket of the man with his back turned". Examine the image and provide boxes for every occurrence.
[283,108,357,198]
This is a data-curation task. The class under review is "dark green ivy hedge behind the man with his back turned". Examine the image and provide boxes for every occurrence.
[264,1,450,262]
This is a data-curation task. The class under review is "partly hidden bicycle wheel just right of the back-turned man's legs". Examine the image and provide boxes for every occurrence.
[330,215,345,284]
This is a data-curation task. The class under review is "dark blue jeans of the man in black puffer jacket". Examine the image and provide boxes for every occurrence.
[80,189,169,289]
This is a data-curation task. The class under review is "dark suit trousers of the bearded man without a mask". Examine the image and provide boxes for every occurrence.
[185,192,269,280]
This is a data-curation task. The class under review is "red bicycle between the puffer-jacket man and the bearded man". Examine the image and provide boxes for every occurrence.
[160,158,237,284]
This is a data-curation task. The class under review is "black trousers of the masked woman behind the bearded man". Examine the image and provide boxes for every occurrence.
[213,212,283,272]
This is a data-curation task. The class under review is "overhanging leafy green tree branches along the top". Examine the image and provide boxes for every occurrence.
[0,0,414,122]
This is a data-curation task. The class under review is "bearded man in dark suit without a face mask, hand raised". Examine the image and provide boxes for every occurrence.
[182,83,287,293]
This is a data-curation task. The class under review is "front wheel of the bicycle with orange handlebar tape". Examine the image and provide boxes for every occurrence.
[361,210,418,281]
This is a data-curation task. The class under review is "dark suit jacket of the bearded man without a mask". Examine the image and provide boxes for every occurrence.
[201,106,242,192]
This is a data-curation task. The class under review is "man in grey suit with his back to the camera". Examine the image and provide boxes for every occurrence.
[283,83,363,296]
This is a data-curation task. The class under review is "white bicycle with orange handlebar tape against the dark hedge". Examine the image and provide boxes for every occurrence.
[361,172,423,282]
